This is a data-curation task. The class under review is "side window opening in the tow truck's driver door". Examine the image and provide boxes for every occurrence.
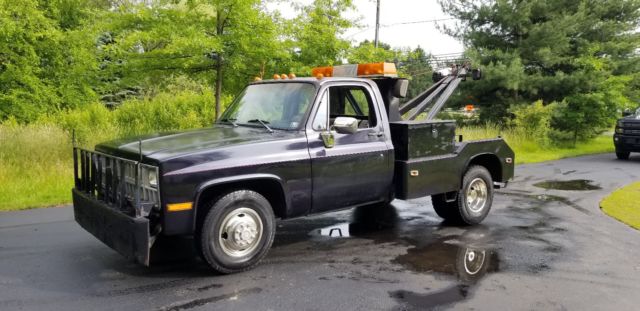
[329,86,377,128]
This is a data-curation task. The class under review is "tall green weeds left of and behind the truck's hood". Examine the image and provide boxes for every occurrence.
[0,89,222,211]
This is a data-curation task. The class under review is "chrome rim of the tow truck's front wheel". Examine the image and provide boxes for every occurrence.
[218,207,263,258]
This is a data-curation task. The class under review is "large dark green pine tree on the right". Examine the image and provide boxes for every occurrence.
[440,0,640,138]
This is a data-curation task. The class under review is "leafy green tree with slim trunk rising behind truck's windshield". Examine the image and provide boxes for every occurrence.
[94,0,284,118]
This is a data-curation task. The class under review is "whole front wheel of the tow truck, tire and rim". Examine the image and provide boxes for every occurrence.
[196,190,275,274]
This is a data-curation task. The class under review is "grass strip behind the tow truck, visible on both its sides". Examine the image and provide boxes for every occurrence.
[0,119,613,211]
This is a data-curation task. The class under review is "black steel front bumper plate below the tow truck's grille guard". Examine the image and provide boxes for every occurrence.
[72,189,151,266]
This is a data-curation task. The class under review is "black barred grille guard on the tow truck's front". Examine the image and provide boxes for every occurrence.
[73,147,160,217]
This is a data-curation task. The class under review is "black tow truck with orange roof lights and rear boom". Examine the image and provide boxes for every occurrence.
[72,63,514,273]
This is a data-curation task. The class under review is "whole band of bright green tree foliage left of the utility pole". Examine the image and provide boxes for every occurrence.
[0,0,352,122]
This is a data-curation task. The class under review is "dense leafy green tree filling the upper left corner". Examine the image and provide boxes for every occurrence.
[0,0,96,122]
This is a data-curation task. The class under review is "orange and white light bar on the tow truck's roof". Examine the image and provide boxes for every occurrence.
[311,63,398,78]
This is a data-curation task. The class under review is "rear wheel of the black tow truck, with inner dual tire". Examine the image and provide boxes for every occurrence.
[431,165,493,225]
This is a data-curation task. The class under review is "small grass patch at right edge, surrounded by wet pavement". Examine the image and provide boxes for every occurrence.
[600,182,640,230]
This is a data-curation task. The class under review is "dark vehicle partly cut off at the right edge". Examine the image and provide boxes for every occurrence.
[613,108,640,160]
